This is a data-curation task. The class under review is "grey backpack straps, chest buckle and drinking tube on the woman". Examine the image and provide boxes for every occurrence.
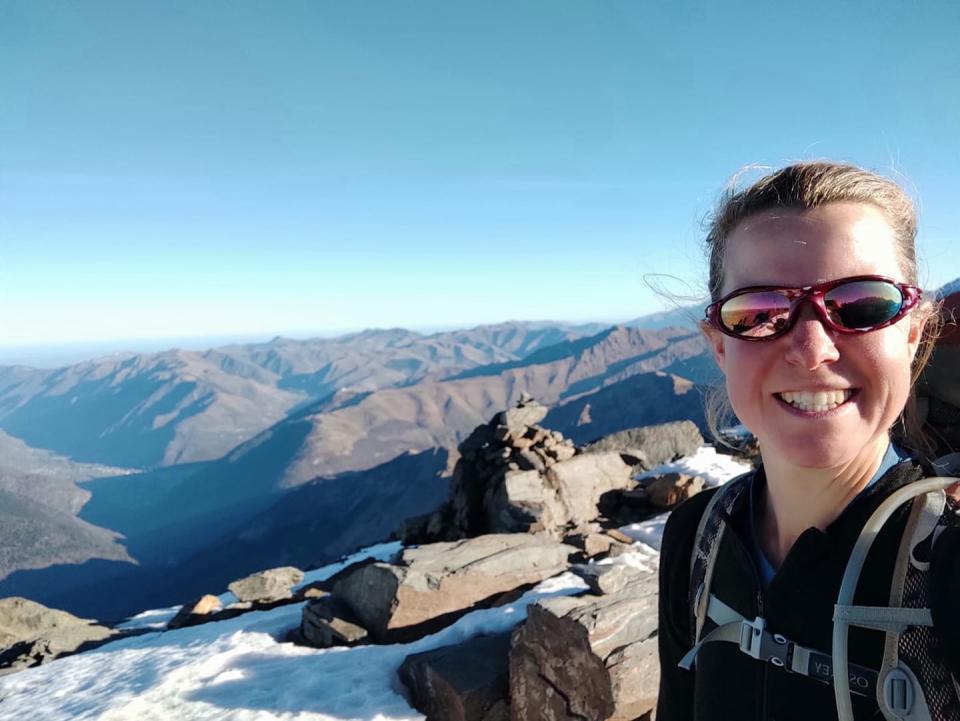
[679,454,960,721]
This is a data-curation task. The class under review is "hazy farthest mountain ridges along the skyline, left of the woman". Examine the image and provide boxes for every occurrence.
[0,323,595,468]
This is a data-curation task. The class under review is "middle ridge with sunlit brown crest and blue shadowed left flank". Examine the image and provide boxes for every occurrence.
[71,328,704,563]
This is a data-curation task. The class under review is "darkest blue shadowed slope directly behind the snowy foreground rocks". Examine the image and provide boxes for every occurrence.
[0,449,449,621]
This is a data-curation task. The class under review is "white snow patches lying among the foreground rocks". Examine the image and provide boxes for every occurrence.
[0,447,746,721]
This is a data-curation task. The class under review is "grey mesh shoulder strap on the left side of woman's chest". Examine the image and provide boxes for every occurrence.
[689,471,754,646]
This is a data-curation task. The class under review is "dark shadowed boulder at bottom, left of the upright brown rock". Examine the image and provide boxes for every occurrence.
[398,632,510,721]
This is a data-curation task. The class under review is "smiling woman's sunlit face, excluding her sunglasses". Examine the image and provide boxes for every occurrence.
[707,203,923,468]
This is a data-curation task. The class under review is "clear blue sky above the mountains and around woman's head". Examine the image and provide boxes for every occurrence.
[0,0,960,346]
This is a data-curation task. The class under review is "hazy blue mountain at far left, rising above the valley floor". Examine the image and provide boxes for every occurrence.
[0,351,299,467]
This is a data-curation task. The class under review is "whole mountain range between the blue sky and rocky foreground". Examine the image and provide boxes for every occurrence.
[0,319,715,617]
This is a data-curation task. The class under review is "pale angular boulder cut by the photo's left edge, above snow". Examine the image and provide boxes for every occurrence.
[0,597,116,674]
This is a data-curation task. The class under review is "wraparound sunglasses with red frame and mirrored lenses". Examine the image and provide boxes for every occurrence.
[706,275,920,340]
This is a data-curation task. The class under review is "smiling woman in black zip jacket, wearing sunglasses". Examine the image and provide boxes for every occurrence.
[657,163,960,721]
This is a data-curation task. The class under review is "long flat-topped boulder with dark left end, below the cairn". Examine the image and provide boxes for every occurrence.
[333,534,576,642]
